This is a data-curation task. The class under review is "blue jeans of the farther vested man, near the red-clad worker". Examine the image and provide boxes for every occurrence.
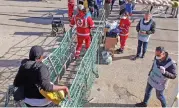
[137,40,148,56]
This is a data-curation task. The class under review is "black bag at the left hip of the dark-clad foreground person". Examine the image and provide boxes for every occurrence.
[13,86,25,101]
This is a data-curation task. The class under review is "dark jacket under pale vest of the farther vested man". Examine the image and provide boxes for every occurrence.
[136,19,156,35]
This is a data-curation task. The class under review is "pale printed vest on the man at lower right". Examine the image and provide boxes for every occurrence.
[148,60,175,90]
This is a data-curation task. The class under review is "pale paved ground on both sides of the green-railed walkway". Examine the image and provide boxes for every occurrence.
[0,0,178,106]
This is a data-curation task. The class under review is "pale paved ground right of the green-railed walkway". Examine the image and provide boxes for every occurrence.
[87,3,178,107]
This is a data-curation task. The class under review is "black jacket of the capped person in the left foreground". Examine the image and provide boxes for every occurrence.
[13,59,53,99]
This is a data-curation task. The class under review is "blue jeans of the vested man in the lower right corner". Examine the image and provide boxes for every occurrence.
[143,83,167,107]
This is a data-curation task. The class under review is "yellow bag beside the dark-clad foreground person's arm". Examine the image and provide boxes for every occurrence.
[40,89,65,104]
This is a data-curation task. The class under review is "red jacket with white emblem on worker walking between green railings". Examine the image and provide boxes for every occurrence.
[70,11,94,36]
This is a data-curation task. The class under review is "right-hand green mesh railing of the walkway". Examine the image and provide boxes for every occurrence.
[62,10,105,107]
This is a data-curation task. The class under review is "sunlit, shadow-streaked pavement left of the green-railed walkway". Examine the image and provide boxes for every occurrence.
[0,0,68,106]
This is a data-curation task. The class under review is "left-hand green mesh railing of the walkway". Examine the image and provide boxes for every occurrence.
[43,29,76,83]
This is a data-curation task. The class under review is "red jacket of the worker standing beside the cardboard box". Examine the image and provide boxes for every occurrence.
[119,18,131,36]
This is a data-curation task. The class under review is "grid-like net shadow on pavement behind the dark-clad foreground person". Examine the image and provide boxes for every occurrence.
[0,34,63,104]
